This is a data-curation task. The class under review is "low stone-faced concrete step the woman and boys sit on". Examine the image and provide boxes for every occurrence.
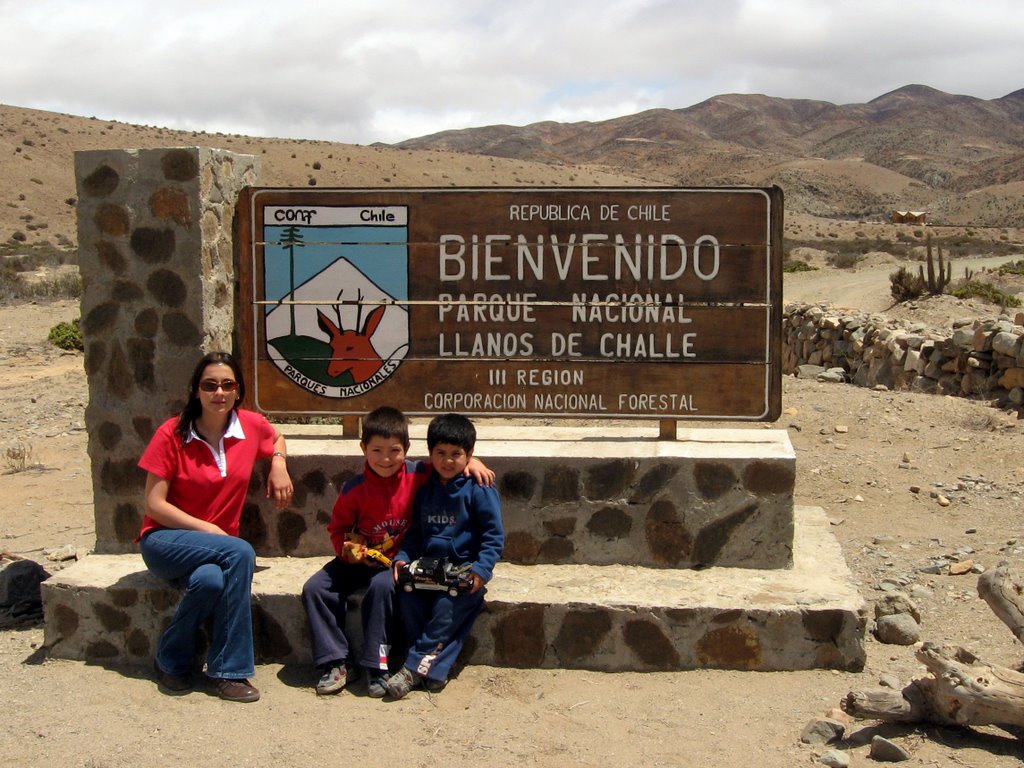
[42,506,866,672]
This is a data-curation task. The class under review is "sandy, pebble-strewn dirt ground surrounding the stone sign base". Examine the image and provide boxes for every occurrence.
[0,264,1024,768]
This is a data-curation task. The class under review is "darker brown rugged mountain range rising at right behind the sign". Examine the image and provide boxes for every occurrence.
[398,85,1024,226]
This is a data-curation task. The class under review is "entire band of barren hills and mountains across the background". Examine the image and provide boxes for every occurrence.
[0,85,1024,252]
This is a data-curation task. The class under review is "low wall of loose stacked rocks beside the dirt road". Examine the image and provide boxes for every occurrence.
[782,304,1024,409]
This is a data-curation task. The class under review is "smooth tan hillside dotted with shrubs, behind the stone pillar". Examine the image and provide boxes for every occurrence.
[0,104,643,251]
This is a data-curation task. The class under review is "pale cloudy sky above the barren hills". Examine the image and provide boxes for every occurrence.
[0,0,1024,143]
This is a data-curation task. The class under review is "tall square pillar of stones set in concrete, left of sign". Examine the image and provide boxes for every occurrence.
[75,147,259,553]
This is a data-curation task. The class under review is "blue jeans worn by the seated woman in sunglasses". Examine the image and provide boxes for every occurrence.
[139,528,256,680]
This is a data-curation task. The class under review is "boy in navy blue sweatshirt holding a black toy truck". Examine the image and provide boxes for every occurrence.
[386,414,505,698]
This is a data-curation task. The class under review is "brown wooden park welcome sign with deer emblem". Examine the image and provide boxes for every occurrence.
[238,187,782,420]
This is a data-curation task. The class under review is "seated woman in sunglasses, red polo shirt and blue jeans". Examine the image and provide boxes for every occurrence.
[138,352,292,701]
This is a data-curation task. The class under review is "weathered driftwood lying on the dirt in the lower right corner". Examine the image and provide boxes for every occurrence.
[841,562,1024,727]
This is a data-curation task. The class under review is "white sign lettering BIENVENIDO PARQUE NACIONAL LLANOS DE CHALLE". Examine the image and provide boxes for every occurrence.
[430,232,704,359]
